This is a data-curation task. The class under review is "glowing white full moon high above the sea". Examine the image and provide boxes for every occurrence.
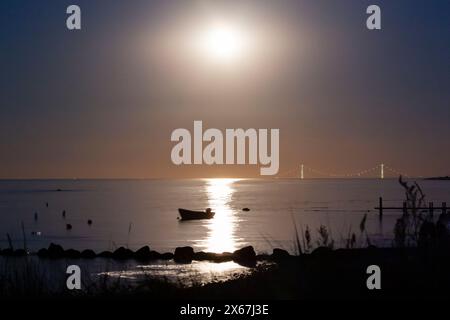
[199,24,245,63]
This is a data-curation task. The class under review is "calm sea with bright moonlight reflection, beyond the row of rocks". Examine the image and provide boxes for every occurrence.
[0,179,450,253]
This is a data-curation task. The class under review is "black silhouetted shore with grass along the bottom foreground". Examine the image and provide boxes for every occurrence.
[0,245,450,300]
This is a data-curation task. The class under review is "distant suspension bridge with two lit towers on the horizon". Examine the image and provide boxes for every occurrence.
[278,163,422,179]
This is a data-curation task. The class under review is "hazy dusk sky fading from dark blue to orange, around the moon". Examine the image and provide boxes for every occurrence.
[0,0,450,178]
